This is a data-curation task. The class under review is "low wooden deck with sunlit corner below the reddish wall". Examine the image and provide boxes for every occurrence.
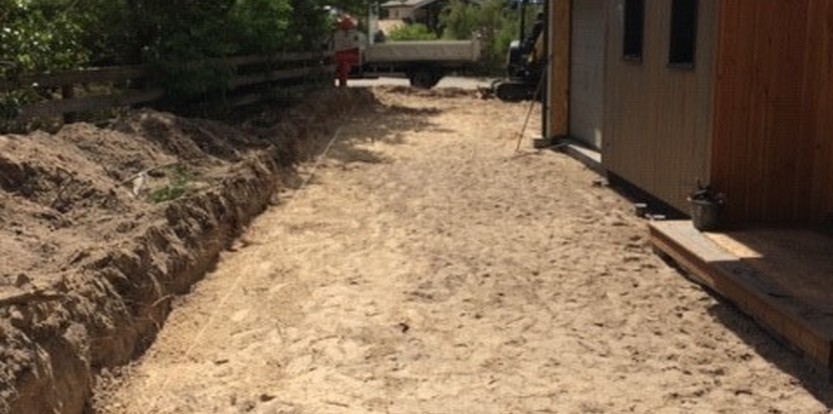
[649,220,833,372]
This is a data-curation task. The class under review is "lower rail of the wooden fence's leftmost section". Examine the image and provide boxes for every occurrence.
[18,89,164,121]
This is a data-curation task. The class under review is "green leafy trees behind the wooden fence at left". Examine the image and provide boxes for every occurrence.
[0,0,344,109]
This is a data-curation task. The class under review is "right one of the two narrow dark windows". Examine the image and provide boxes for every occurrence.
[668,0,697,68]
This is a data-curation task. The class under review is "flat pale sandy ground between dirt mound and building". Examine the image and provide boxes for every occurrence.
[95,88,833,414]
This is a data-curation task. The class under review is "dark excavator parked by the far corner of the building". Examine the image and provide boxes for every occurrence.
[492,0,546,102]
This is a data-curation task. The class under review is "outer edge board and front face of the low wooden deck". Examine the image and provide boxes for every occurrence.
[649,221,833,369]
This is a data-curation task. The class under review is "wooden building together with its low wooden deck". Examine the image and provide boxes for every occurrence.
[544,0,833,373]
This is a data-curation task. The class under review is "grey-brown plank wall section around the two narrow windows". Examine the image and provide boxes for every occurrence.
[602,0,720,211]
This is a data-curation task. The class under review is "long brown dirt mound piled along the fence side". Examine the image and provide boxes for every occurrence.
[0,90,372,413]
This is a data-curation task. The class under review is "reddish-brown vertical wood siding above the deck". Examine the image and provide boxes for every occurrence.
[712,0,833,223]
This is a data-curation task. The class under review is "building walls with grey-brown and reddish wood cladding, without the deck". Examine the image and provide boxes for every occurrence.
[544,0,833,224]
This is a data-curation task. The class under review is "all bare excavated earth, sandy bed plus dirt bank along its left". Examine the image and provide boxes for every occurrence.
[0,87,833,414]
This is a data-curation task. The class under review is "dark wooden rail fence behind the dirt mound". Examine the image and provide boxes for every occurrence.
[0,52,335,122]
